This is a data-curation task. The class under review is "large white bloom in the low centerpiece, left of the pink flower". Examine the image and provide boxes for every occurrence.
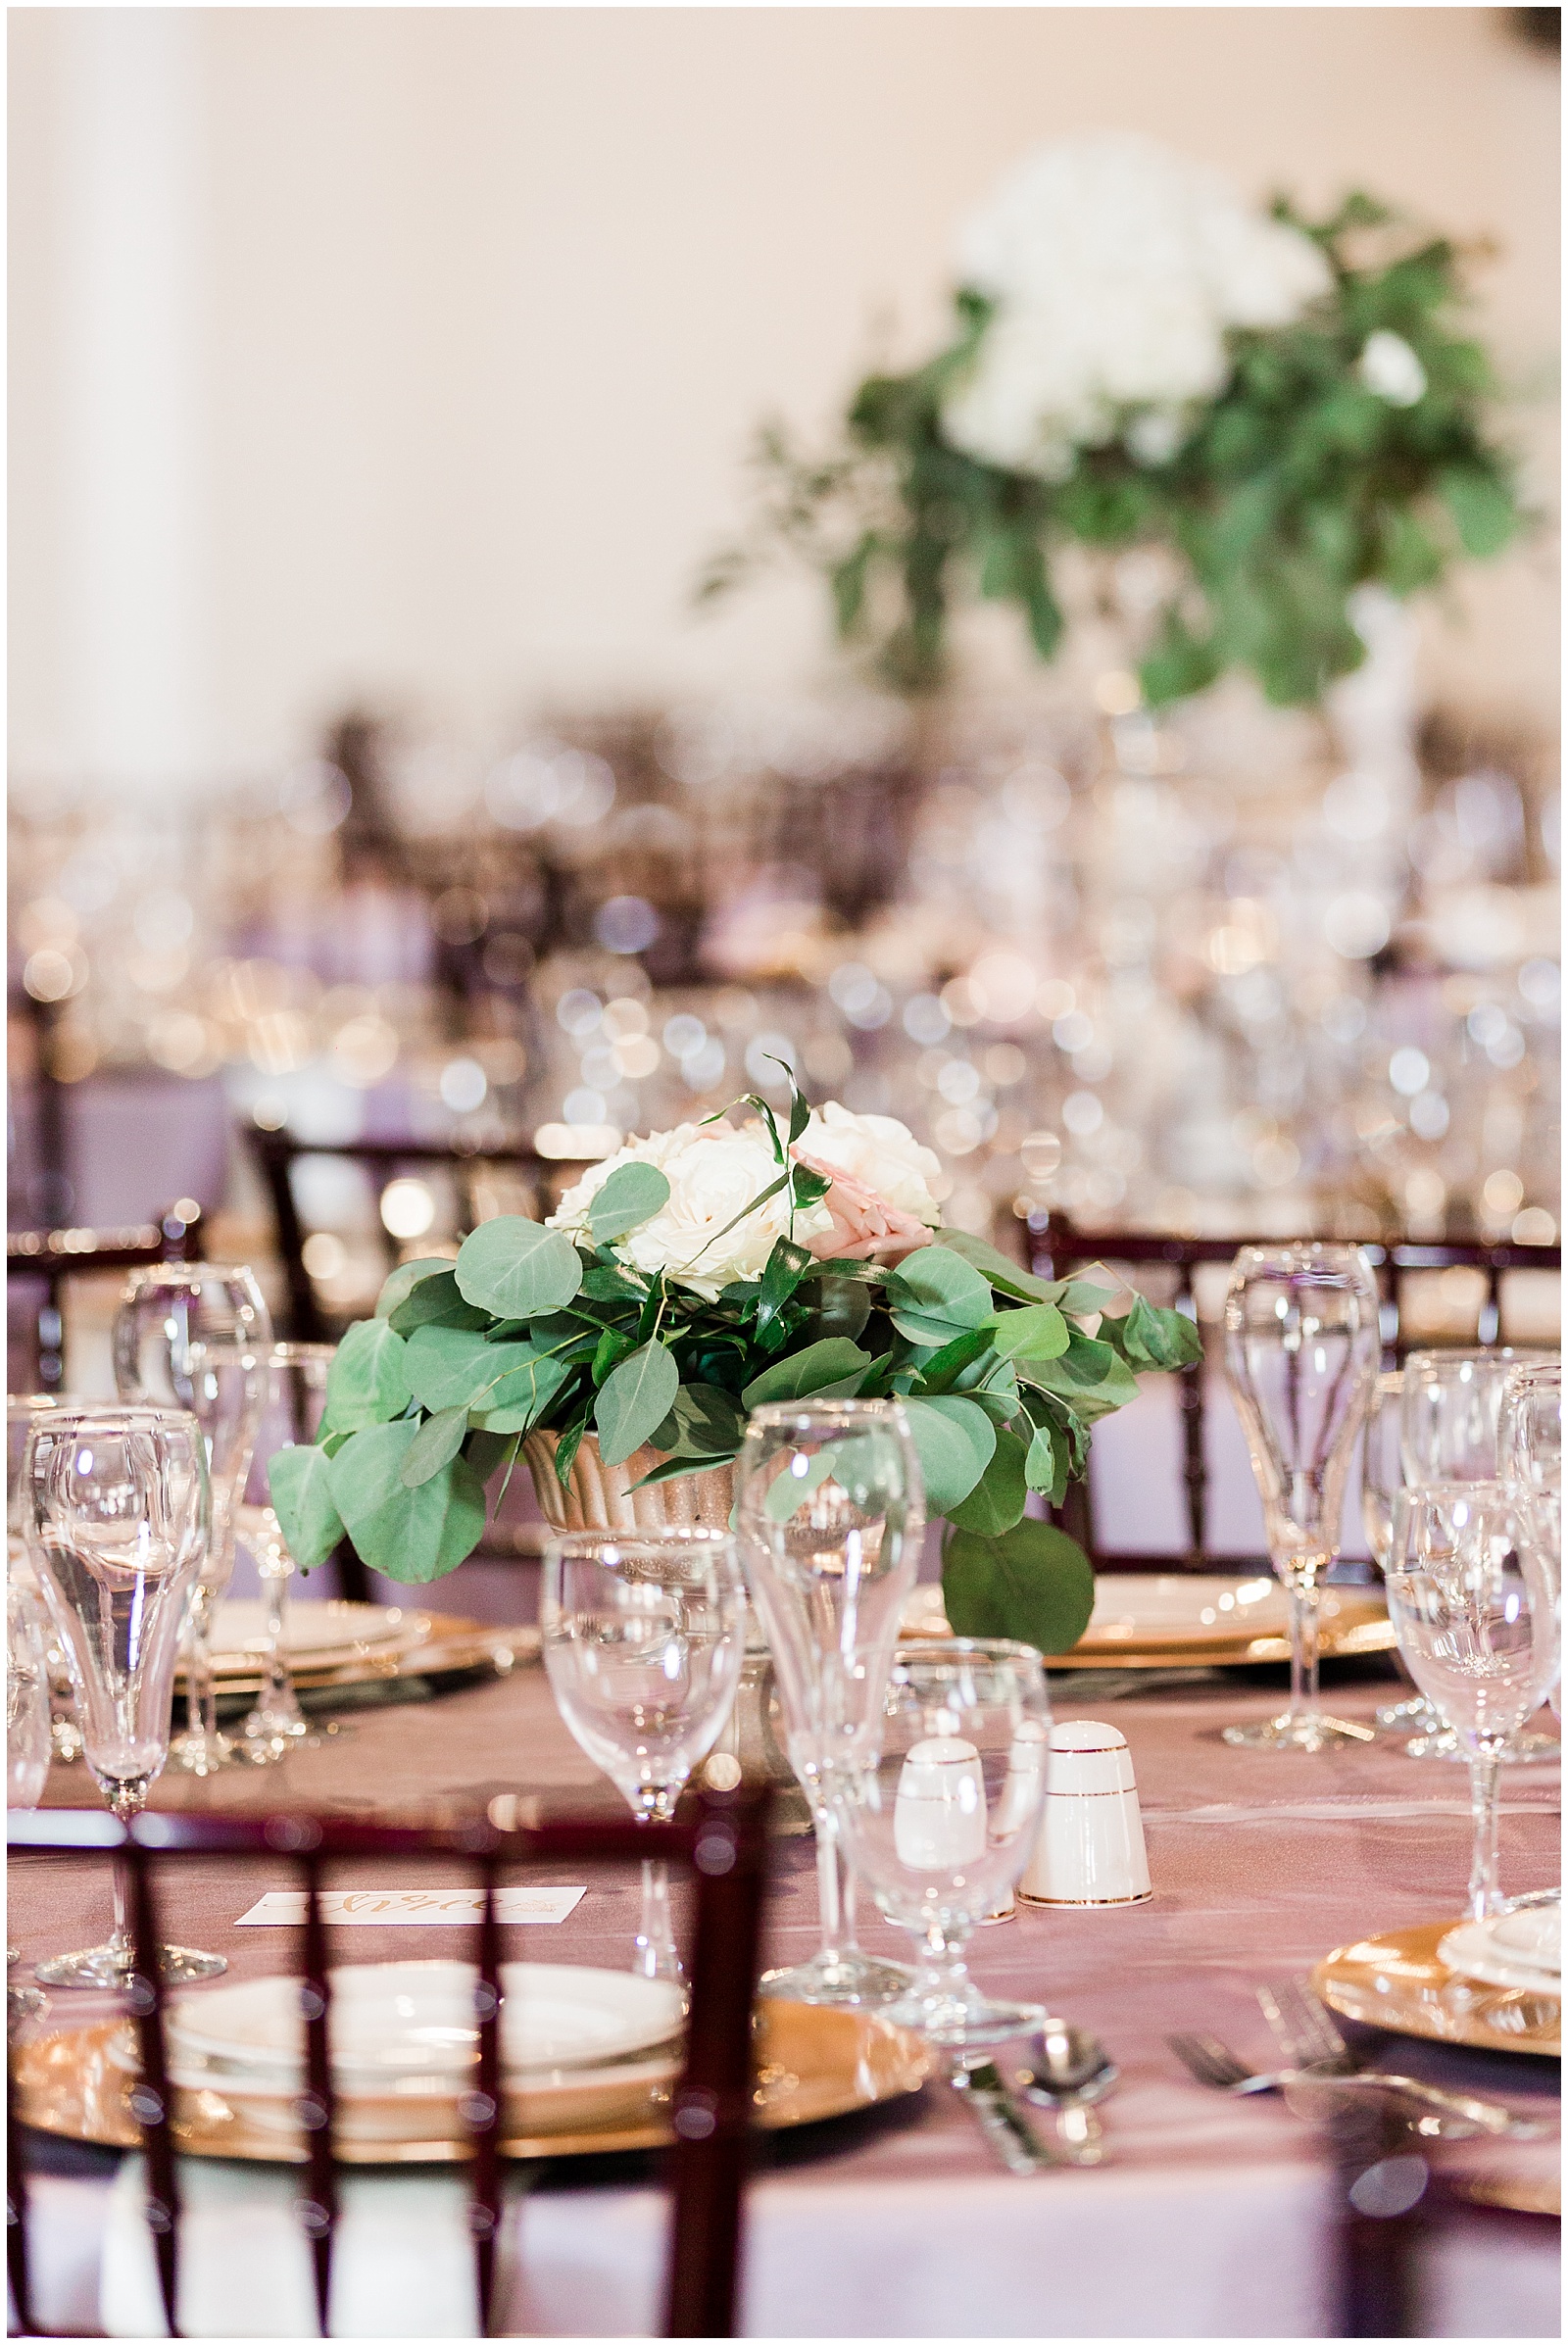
[549,1123,832,1301]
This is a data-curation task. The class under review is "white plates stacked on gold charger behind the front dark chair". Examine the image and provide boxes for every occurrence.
[169,1961,682,2080]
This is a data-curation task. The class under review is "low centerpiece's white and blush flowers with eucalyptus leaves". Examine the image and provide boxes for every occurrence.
[271,1088,1202,1651]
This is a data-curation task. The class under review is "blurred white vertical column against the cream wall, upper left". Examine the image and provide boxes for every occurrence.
[59,10,209,793]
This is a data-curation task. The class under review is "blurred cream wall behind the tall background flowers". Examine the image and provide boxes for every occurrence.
[10,7,1558,778]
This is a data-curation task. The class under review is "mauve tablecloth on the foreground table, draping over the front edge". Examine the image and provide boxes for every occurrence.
[10,1667,1558,2338]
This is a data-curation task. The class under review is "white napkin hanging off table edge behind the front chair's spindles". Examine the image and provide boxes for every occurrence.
[98,2158,527,2338]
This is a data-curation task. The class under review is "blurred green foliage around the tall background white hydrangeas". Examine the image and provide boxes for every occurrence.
[701,192,1524,703]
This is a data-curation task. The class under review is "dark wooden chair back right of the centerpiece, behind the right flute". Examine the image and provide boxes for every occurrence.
[1029,1215,1563,1571]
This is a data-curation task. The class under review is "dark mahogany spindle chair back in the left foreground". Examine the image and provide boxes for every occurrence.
[7,1786,766,2335]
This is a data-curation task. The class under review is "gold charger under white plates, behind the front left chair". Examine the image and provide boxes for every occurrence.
[12,2000,930,2167]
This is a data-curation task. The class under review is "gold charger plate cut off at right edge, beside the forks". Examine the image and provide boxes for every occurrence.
[1312,1921,1563,2059]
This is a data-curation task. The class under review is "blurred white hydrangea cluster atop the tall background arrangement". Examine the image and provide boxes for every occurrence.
[942,133,1331,478]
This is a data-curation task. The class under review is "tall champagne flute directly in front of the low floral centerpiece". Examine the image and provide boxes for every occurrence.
[734,1400,926,2005]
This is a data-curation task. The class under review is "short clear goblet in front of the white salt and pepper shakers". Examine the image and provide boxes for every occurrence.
[827,1637,1050,2047]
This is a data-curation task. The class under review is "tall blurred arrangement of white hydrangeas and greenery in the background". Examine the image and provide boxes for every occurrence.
[701,136,1521,706]
